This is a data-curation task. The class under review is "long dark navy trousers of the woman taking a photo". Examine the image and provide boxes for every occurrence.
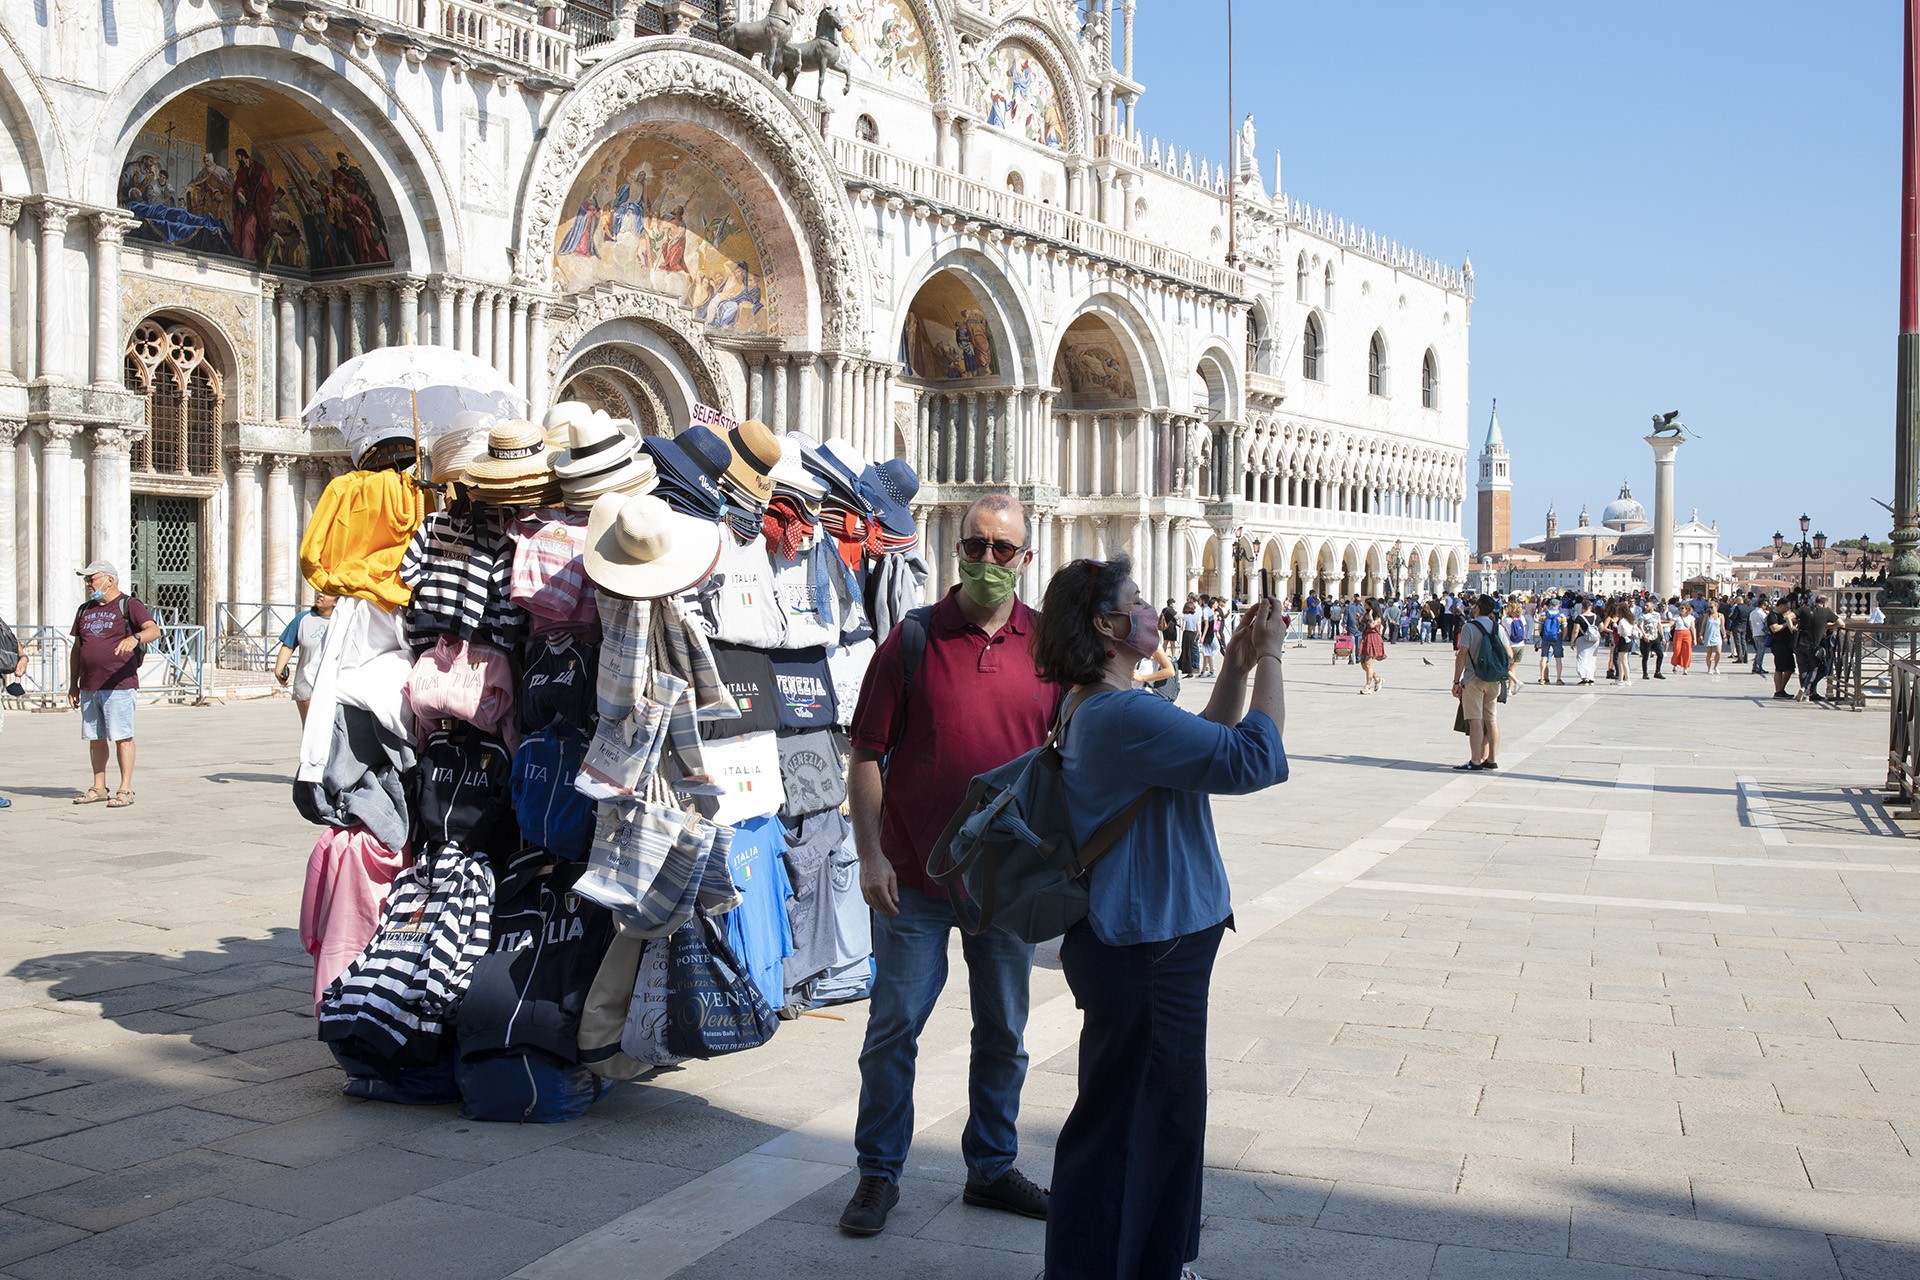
[1046,921,1225,1280]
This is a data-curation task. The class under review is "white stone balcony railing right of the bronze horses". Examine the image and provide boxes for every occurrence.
[831,138,1246,297]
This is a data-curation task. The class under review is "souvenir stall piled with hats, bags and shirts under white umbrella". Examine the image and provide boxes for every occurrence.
[294,347,925,1121]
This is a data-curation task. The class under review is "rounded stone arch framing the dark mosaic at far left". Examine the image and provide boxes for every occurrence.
[79,21,463,273]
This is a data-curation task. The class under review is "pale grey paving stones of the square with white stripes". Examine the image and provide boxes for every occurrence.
[0,643,1920,1280]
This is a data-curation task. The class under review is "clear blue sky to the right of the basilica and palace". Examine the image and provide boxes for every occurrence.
[1116,0,1901,553]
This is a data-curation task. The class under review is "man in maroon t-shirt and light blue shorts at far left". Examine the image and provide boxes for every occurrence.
[67,560,159,810]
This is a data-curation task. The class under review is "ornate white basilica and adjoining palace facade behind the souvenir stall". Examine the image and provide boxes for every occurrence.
[0,0,1473,626]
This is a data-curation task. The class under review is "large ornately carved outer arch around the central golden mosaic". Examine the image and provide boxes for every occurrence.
[515,36,872,351]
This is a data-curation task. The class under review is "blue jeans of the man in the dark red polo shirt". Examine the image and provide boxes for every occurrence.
[852,889,1033,1182]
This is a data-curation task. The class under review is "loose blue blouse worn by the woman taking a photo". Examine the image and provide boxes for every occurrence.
[1062,689,1286,946]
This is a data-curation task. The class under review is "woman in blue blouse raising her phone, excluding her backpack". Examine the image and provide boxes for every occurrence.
[1033,557,1286,1280]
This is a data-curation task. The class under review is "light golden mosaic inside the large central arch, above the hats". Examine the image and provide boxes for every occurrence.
[553,136,778,334]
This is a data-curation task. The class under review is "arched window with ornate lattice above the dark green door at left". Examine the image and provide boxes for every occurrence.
[123,317,225,476]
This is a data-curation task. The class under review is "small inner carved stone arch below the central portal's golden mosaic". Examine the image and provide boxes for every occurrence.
[547,284,741,420]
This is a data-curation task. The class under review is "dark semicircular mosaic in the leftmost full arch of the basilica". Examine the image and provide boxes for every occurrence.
[119,84,392,271]
